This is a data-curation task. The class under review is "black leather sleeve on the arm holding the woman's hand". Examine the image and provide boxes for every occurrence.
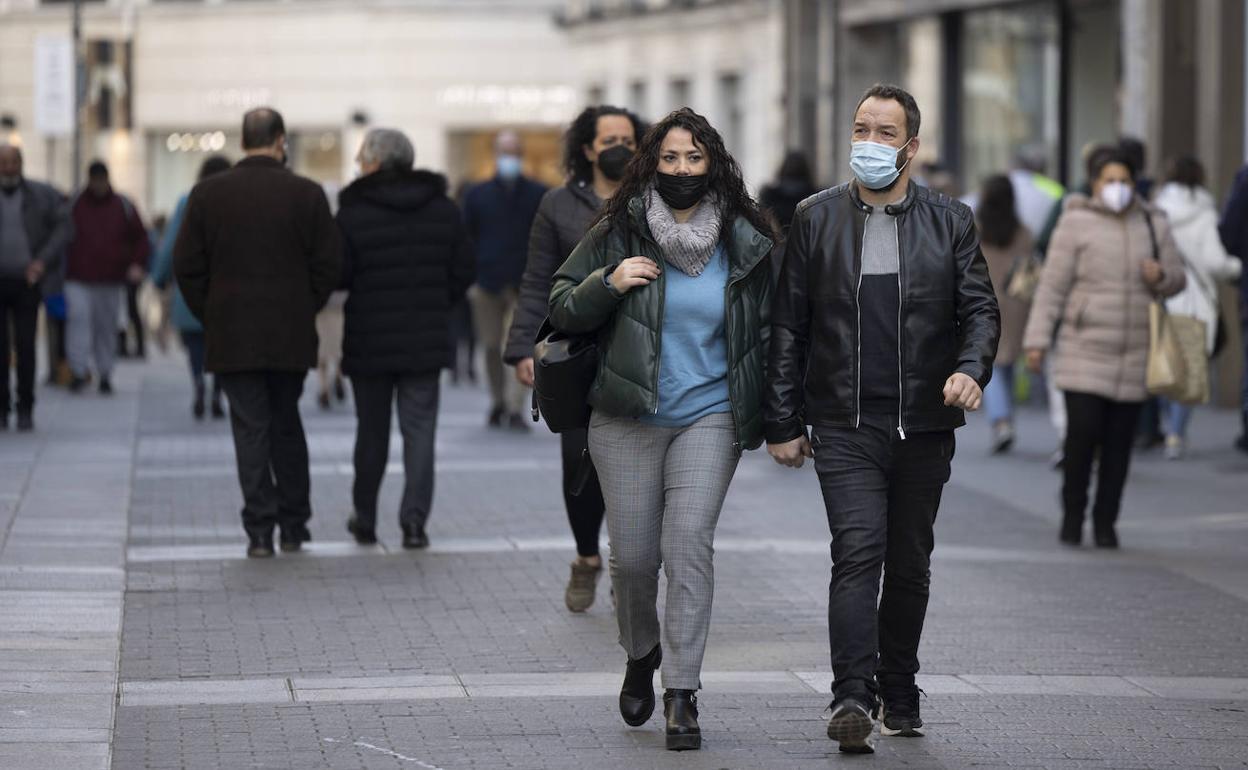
[764,204,812,444]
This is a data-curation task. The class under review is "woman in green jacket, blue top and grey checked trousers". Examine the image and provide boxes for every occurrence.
[550,107,773,750]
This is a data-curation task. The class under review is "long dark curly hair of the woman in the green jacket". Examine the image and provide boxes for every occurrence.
[598,107,775,241]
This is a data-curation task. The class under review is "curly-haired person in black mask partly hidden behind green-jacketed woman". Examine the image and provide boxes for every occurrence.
[503,105,645,613]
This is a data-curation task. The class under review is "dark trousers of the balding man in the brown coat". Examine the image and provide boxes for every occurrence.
[217,372,312,537]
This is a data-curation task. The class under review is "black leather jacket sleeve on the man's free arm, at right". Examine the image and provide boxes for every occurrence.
[953,210,1001,388]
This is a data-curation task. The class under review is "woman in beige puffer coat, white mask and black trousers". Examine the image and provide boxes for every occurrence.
[1023,147,1186,548]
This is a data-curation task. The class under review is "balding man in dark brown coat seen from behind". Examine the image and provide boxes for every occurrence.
[173,109,342,558]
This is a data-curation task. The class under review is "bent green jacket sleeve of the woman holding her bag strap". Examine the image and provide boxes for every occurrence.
[550,222,624,334]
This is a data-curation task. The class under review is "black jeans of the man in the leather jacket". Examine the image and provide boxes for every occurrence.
[814,414,955,698]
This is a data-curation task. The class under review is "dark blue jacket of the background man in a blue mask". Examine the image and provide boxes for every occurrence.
[464,176,547,292]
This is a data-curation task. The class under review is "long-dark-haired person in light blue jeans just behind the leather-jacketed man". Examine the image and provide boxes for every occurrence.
[976,175,1036,453]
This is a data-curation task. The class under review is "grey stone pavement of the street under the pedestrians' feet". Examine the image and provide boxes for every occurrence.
[0,356,1248,769]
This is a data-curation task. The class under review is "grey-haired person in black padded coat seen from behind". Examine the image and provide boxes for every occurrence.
[338,129,474,548]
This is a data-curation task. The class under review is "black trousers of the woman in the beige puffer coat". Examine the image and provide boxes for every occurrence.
[1062,392,1143,532]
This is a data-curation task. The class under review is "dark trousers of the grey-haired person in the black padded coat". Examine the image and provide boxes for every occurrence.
[351,372,439,529]
